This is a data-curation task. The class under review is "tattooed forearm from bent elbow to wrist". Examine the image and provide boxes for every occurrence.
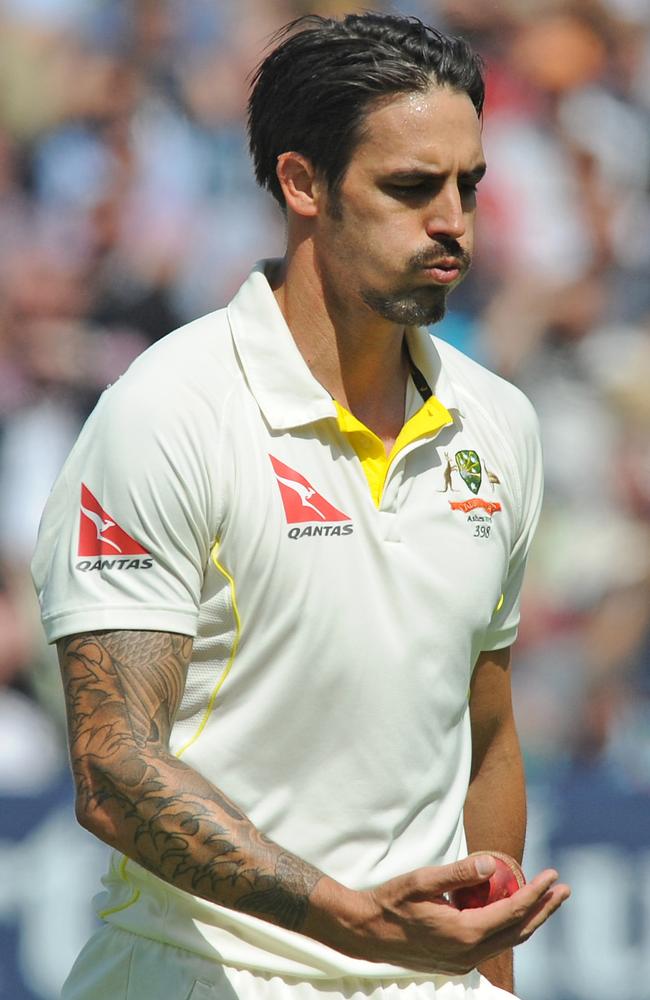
[75,747,334,930]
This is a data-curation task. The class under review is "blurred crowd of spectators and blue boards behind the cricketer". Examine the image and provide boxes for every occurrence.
[0,0,650,1000]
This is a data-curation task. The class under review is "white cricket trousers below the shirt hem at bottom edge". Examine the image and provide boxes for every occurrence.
[61,925,513,1000]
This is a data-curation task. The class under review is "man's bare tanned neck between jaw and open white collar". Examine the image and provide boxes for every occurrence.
[269,241,409,440]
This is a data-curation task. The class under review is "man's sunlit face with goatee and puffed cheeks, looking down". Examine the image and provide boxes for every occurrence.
[315,86,485,325]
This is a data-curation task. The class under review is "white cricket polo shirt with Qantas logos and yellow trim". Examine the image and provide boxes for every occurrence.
[33,262,542,978]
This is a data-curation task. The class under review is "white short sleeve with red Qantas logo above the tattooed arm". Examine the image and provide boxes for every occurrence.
[32,372,218,642]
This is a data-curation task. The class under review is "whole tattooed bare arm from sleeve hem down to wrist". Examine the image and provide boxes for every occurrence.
[59,631,322,930]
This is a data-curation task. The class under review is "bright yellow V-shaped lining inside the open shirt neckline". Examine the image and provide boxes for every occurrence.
[334,396,453,507]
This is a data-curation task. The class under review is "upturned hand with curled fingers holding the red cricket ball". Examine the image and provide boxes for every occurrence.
[304,854,570,975]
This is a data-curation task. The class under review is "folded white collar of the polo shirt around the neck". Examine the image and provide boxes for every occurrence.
[227,260,457,431]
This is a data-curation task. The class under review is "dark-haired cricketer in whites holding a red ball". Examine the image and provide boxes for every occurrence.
[34,14,568,1000]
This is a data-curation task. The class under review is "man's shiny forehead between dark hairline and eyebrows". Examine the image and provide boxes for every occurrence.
[350,86,483,171]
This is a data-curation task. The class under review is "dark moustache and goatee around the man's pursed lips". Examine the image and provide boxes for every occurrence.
[361,240,471,326]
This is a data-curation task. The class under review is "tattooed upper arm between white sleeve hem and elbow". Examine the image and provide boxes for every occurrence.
[57,630,192,759]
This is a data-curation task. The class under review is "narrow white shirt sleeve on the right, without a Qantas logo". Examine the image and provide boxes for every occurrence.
[483,393,544,651]
